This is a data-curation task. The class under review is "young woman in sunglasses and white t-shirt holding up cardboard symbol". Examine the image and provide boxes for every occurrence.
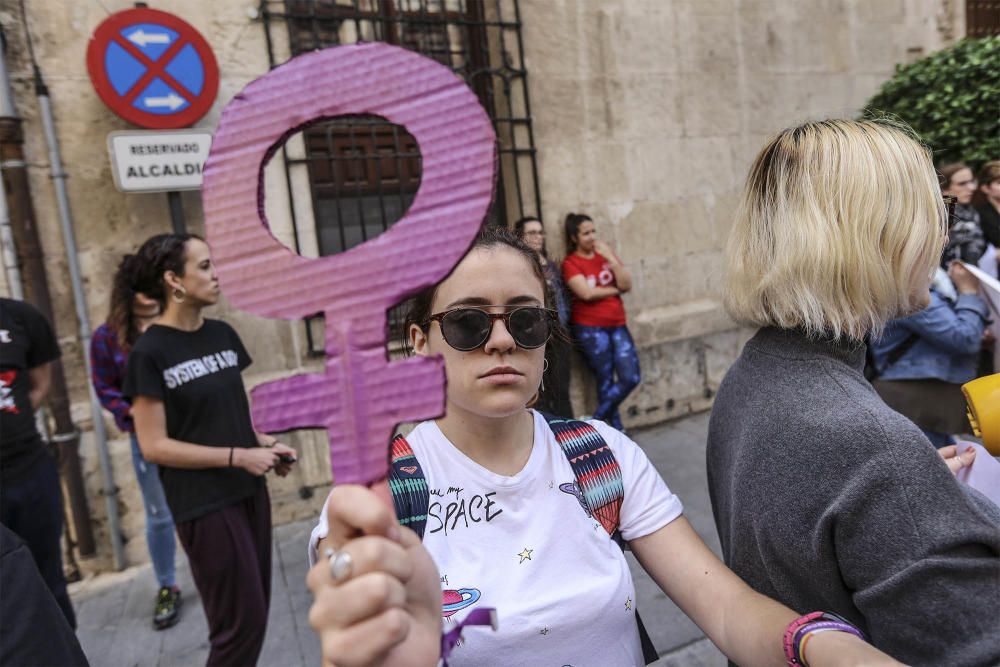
[300,230,896,667]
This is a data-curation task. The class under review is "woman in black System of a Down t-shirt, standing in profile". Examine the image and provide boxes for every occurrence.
[124,234,295,665]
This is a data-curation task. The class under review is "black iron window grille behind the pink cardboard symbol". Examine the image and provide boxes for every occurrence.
[254,0,541,356]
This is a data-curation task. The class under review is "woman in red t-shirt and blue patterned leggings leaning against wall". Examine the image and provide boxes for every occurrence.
[563,213,639,430]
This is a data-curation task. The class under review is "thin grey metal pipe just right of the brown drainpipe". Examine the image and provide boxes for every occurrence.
[35,67,125,570]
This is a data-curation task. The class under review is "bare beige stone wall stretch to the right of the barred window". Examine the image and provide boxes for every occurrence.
[522,0,964,426]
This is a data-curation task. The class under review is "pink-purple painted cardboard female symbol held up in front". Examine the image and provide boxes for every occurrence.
[202,43,496,483]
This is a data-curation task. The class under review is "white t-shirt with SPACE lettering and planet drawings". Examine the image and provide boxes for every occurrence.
[310,412,683,667]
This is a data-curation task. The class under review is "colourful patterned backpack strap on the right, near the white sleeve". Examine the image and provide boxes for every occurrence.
[542,413,625,537]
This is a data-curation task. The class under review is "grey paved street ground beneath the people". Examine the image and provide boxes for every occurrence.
[70,413,726,667]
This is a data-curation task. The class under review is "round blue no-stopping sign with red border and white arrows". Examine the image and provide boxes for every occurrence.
[87,7,219,130]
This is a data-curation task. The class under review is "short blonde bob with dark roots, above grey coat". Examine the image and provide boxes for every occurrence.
[725,120,947,341]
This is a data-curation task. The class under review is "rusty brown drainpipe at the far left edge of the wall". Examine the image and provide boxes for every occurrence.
[0,29,96,556]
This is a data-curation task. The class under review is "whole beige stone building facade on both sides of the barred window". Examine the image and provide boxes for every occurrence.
[0,0,964,569]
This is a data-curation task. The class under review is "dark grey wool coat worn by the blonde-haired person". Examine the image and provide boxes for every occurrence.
[708,328,1000,667]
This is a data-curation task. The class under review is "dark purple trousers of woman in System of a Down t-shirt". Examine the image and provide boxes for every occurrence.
[177,485,271,667]
